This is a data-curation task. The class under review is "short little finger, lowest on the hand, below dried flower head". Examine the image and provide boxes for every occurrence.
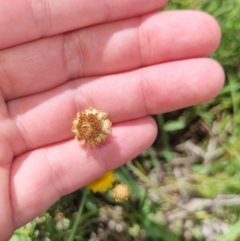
[11,118,157,227]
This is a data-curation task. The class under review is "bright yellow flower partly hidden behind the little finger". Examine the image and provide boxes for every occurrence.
[86,171,115,192]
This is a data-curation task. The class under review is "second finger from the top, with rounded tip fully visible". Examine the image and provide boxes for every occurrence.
[0,11,220,99]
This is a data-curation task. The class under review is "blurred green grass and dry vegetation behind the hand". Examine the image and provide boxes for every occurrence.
[11,0,240,241]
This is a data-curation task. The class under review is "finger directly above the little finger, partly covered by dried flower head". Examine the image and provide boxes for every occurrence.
[8,59,224,154]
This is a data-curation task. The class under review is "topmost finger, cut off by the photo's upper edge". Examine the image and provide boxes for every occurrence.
[0,0,167,49]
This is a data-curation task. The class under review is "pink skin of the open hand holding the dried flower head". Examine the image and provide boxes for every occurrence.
[0,0,224,241]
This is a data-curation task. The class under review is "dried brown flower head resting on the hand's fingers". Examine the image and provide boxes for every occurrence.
[71,108,112,147]
